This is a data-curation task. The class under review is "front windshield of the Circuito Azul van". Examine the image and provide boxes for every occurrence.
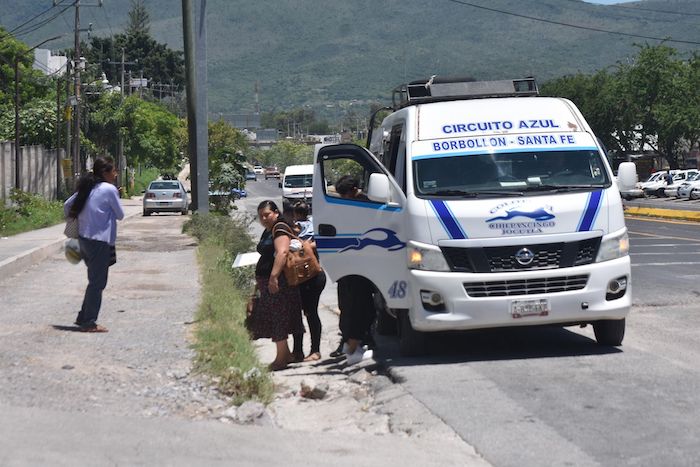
[413,150,610,197]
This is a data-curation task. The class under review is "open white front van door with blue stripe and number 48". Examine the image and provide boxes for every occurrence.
[313,144,409,308]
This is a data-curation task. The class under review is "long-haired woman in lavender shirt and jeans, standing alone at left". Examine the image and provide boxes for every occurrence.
[63,157,124,332]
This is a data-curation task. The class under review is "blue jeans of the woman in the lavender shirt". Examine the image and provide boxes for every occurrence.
[75,237,110,327]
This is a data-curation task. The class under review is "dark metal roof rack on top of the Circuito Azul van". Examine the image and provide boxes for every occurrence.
[391,75,539,109]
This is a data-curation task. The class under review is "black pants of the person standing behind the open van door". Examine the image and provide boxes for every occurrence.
[338,276,376,342]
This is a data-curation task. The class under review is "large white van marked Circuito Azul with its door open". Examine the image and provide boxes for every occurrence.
[313,78,631,355]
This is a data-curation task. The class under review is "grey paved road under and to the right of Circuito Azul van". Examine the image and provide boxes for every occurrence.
[379,219,700,467]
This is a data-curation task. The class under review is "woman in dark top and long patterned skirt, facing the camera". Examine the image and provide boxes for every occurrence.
[248,200,304,371]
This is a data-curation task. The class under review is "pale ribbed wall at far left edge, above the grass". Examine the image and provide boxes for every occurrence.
[0,142,65,205]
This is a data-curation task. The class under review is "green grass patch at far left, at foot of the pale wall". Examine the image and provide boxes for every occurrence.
[0,190,63,236]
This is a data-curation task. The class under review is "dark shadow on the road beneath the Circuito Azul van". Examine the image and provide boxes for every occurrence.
[375,326,622,366]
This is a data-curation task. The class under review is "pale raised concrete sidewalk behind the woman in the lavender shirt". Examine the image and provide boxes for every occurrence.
[0,198,142,280]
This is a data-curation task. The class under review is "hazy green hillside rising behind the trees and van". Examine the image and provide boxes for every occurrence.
[0,0,700,116]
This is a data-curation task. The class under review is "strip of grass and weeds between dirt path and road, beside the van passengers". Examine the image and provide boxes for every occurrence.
[183,214,274,404]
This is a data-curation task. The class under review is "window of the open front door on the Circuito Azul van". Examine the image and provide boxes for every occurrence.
[321,150,381,203]
